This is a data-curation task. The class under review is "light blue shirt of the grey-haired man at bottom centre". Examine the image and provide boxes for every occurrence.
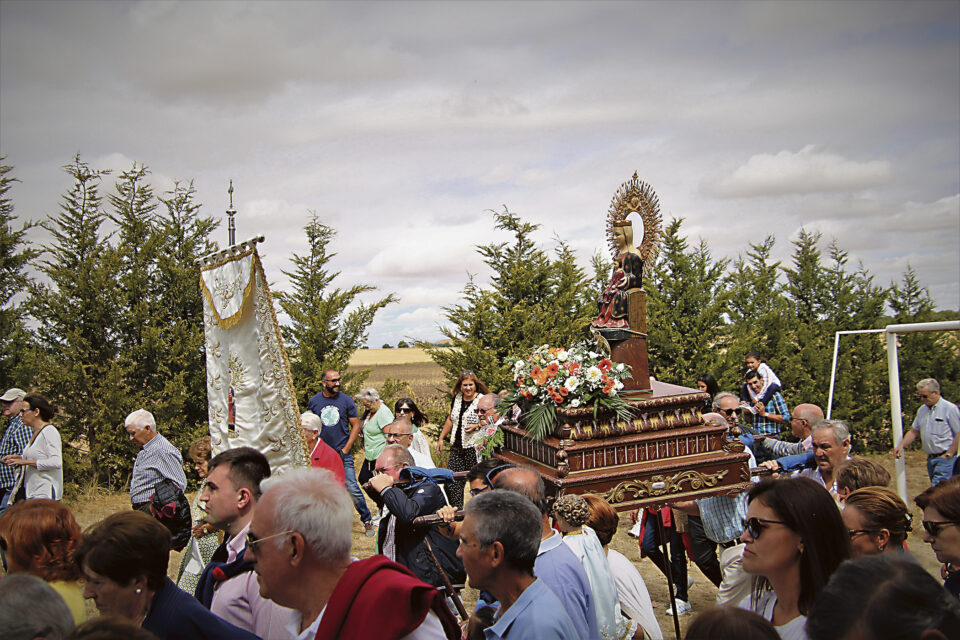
[483,580,576,640]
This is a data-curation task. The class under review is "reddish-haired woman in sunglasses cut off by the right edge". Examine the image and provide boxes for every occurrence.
[913,476,960,596]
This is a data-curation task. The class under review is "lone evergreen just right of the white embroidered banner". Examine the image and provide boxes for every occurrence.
[277,214,397,404]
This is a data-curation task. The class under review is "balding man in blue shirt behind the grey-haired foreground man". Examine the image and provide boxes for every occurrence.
[496,467,598,638]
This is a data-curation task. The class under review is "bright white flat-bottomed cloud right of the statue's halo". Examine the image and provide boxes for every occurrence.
[703,145,893,198]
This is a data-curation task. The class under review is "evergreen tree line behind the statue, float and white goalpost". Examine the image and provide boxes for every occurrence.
[428,209,960,451]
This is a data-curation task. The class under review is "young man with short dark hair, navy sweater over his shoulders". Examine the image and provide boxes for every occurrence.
[196,447,292,640]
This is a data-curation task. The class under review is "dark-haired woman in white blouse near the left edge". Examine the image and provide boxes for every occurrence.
[3,393,63,500]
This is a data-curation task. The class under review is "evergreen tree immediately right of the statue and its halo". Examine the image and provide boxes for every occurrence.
[645,218,729,386]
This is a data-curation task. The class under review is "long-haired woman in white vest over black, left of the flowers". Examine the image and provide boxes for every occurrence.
[437,371,490,508]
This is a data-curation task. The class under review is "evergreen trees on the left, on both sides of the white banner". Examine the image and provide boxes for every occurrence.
[0,155,394,490]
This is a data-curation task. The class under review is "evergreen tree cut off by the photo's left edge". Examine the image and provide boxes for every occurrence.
[0,156,39,389]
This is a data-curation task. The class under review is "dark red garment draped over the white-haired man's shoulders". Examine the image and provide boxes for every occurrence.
[315,555,460,640]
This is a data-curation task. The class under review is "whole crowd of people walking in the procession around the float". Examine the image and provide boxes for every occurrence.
[0,364,960,640]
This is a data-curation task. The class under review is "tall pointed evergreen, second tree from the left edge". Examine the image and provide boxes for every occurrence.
[30,155,130,483]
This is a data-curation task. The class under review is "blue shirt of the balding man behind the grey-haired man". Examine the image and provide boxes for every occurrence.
[536,531,598,640]
